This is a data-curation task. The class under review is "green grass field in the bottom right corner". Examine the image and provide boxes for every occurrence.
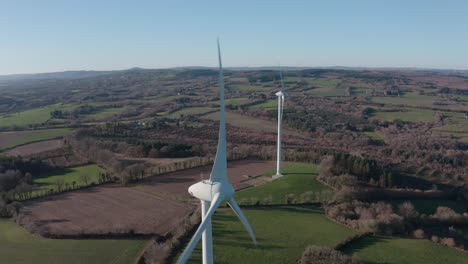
[345,236,468,264]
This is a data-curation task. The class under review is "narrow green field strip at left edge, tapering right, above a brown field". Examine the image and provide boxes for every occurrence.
[0,128,73,150]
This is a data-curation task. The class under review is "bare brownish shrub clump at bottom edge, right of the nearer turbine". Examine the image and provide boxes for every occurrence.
[300,246,363,264]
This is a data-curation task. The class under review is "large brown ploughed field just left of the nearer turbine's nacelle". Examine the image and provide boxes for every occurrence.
[21,185,193,236]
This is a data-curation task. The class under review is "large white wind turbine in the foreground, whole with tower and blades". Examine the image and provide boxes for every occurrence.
[177,39,257,264]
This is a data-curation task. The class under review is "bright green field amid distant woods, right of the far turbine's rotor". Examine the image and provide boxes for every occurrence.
[373,108,435,122]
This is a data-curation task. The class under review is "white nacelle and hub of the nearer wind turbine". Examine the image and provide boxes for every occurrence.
[188,180,234,202]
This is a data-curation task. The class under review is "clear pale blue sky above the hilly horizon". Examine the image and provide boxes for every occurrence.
[0,0,468,74]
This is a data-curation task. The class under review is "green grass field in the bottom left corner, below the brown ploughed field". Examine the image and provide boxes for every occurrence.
[0,219,146,264]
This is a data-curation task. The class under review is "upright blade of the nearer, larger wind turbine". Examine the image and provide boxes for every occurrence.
[210,39,227,182]
